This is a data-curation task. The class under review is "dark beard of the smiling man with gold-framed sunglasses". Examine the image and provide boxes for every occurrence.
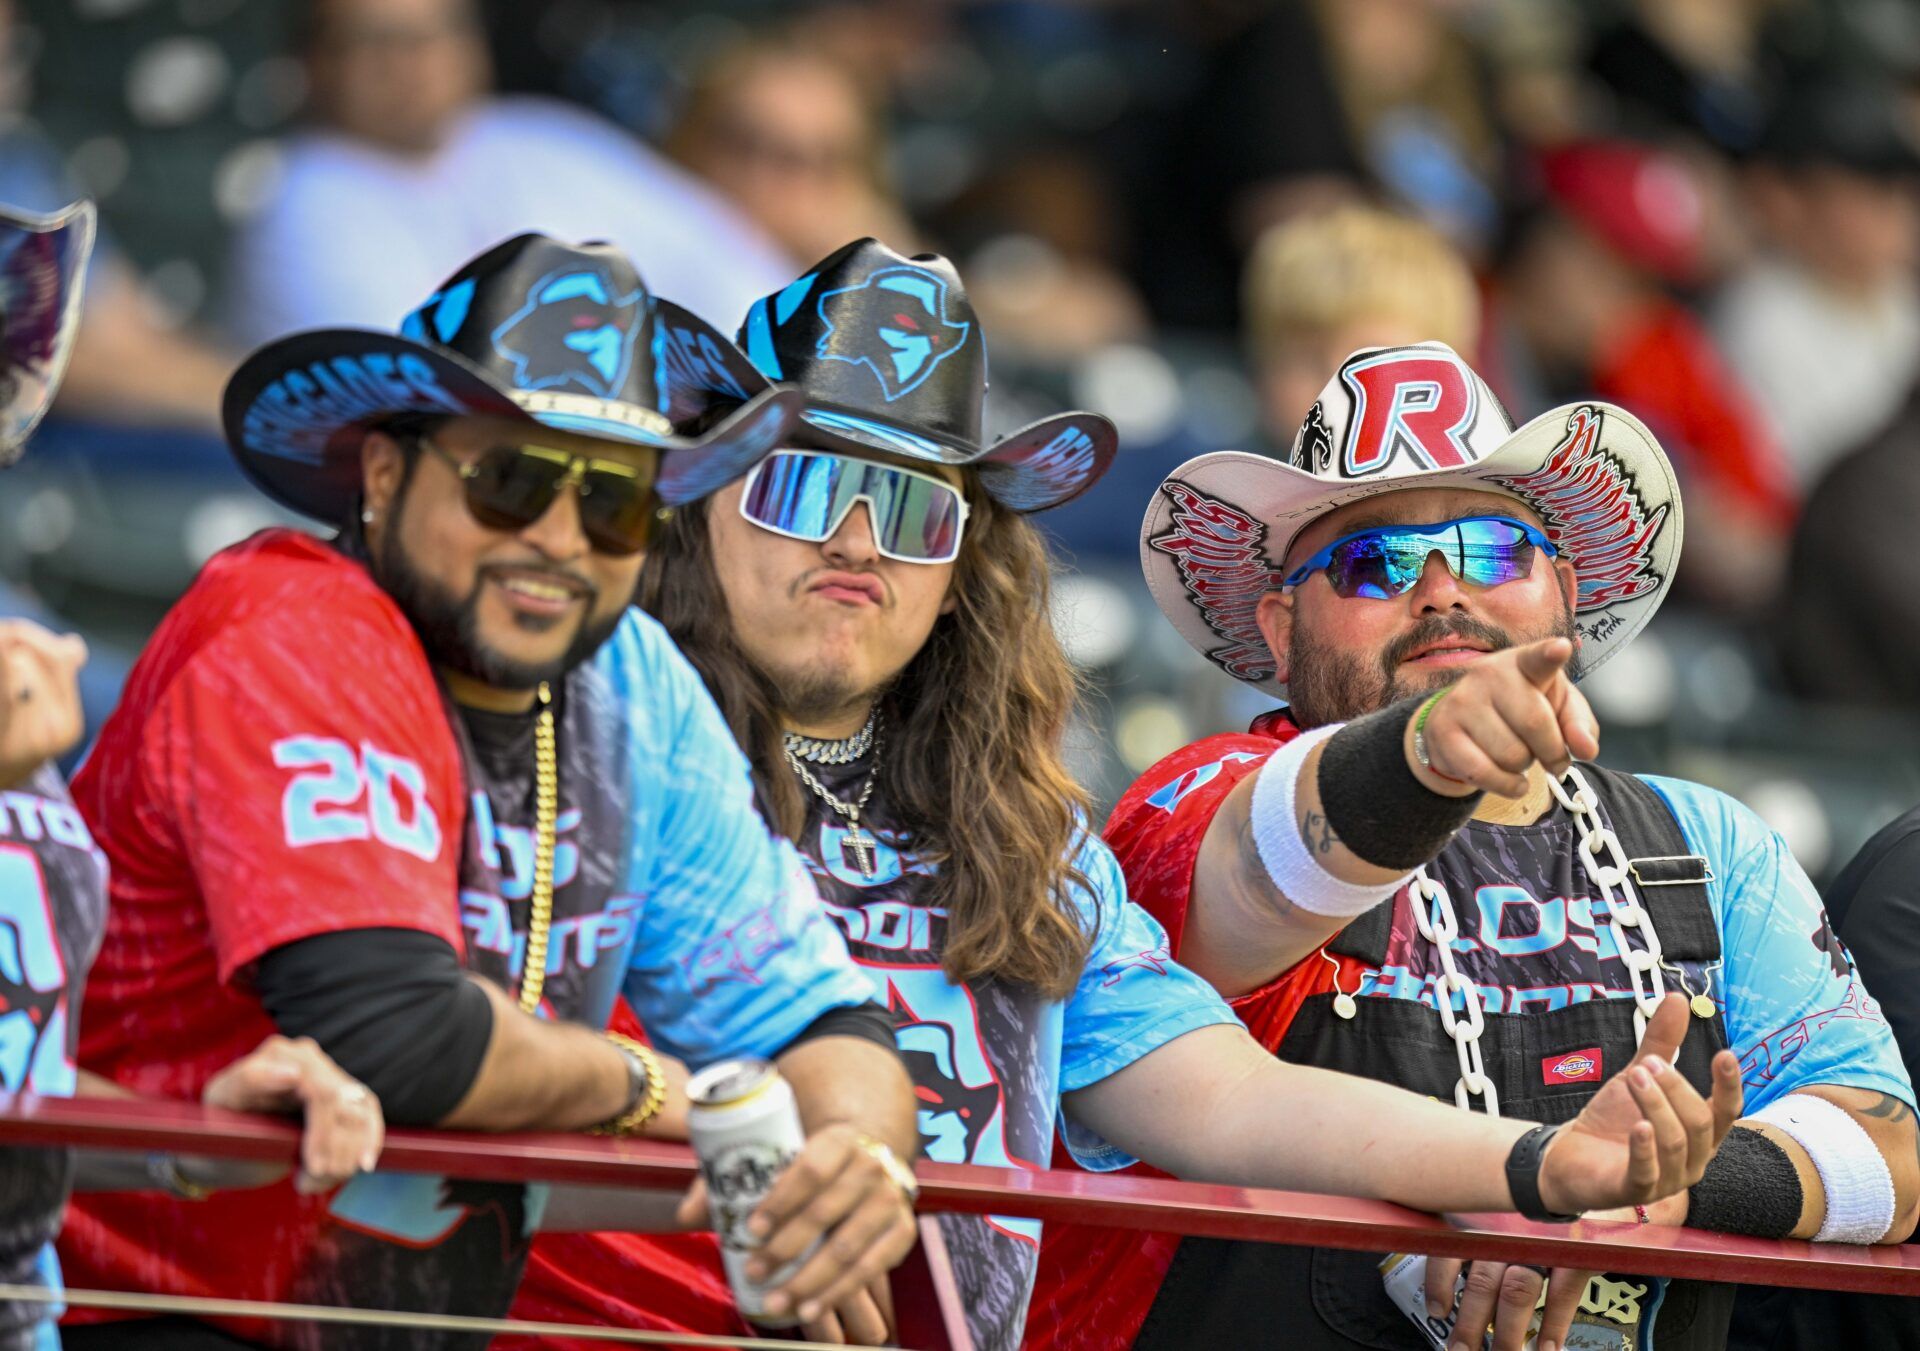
[372,503,620,689]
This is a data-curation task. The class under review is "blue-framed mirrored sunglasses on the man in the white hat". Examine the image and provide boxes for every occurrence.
[1281,516,1559,601]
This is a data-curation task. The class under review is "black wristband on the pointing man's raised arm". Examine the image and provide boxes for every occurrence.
[1319,695,1480,871]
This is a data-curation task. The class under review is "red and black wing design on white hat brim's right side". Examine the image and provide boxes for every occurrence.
[1496,405,1670,614]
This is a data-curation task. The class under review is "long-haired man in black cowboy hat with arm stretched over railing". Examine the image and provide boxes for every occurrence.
[510,240,1740,1349]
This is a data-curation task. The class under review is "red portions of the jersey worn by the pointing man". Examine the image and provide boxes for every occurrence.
[1023,712,1359,1351]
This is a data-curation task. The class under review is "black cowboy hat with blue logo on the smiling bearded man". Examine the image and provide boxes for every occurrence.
[221,234,801,522]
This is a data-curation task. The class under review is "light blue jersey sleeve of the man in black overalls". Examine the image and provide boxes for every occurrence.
[1647,777,1914,1113]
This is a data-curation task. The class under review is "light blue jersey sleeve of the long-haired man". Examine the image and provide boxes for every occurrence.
[1060,835,1236,1171]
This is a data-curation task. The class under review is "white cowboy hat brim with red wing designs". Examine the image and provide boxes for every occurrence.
[1140,403,1684,699]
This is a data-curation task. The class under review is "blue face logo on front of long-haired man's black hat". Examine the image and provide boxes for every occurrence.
[818,267,973,403]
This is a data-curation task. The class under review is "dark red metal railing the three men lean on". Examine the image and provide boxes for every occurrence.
[0,1094,1920,1351]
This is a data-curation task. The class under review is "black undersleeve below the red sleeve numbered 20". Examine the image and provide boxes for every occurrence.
[253,929,493,1126]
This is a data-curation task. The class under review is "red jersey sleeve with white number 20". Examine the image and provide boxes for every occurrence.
[140,604,465,981]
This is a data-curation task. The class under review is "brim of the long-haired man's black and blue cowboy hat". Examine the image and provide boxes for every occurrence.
[655,301,1119,512]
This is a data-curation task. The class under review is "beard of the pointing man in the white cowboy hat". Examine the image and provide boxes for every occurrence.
[1286,593,1580,731]
